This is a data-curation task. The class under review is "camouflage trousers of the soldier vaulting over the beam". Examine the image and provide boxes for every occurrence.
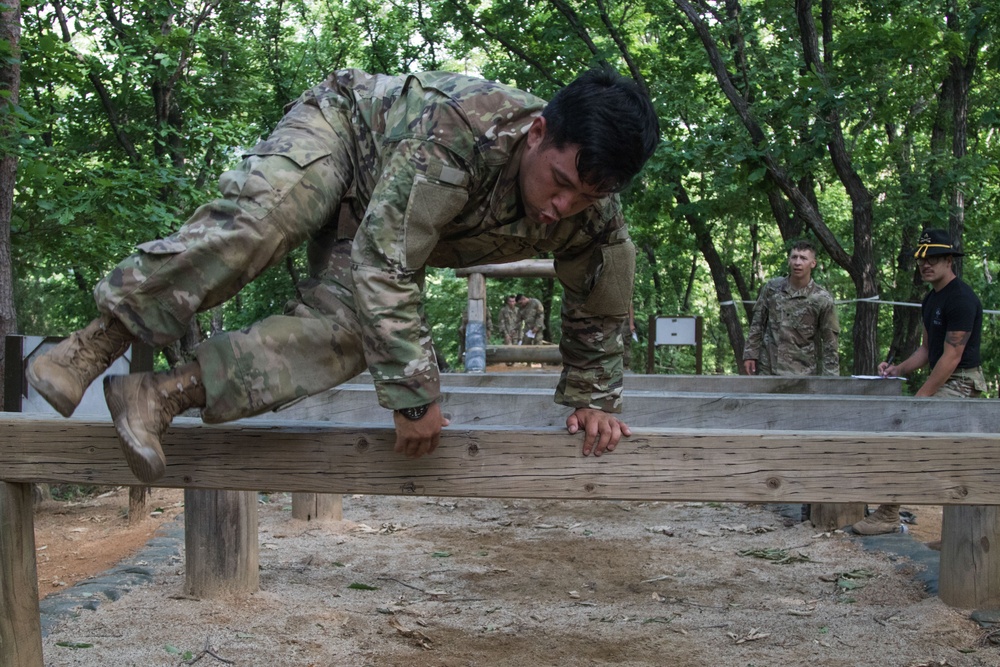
[94,87,376,422]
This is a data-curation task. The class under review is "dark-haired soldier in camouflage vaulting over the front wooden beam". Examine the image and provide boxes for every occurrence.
[28,70,659,483]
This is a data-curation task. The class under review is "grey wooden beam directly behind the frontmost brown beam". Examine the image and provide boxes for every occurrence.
[272,384,1000,433]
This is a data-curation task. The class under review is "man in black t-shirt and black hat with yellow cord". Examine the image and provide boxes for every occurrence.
[852,229,986,535]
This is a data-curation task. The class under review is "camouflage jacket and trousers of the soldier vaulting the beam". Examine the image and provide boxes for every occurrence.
[95,70,635,422]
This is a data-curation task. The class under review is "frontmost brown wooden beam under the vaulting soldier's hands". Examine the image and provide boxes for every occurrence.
[0,413,1000,505]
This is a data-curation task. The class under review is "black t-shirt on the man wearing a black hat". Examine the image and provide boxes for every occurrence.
[921,278,983,368]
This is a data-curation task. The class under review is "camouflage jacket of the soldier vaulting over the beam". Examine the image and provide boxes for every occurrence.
[302,70,635,412]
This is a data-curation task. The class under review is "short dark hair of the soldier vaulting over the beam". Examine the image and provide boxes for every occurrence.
[542,67,660,192]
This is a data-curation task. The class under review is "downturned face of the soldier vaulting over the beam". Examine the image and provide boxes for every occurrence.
[518,116,607,225]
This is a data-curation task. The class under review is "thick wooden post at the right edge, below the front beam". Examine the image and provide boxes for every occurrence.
[938,505,1000,609]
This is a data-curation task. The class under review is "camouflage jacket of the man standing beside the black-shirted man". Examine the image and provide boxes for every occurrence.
[743,277,840,375]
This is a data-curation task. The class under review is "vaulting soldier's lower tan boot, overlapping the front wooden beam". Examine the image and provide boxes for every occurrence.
[104,362,205,484]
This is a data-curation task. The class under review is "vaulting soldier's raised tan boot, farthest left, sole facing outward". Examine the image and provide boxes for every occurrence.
[28,315,135,417]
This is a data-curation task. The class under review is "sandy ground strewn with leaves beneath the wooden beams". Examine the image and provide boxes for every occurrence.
[36,490,1000,667]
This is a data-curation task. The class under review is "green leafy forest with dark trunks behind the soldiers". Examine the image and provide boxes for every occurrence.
[0,0,1000,396]
